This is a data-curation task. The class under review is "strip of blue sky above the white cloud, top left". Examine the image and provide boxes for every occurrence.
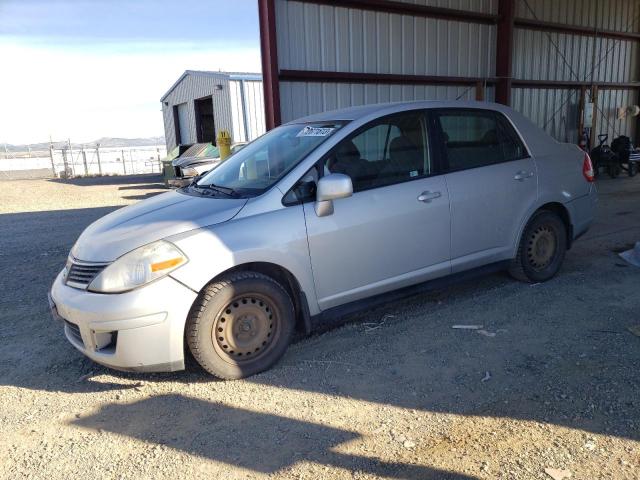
[0,0,259,47]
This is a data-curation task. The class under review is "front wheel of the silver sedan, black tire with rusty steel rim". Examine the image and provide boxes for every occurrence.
[185,272,295,380]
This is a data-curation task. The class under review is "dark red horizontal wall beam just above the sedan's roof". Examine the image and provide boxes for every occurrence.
[279,70,496,86]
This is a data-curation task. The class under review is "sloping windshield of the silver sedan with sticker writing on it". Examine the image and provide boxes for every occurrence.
[193,122,343,197]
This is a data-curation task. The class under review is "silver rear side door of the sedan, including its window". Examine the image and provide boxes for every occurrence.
[432,108,538,272]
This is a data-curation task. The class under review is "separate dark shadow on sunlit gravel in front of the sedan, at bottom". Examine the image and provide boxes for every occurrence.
[73,395,475,480]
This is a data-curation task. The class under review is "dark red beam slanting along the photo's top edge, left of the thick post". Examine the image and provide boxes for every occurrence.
[297,0,498,25]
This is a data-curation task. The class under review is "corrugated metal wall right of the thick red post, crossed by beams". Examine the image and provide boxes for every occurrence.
[512,0,640,143]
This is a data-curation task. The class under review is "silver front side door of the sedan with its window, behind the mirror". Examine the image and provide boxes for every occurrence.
[304,111,450,310]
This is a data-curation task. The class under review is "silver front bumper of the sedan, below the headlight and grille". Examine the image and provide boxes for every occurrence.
[49,274,197,372]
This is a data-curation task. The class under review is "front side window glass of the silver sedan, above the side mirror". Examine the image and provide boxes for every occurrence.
[324,112,432,192]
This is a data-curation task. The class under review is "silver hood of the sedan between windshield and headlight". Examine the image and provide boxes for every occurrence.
[71,191,247,262]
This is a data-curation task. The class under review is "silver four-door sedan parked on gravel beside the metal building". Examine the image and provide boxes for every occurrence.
[50,102,597,379]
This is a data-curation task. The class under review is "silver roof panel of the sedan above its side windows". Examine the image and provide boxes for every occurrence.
[289,100,512,123]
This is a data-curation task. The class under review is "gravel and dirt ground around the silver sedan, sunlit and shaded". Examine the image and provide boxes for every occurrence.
[0,176,640,480]
